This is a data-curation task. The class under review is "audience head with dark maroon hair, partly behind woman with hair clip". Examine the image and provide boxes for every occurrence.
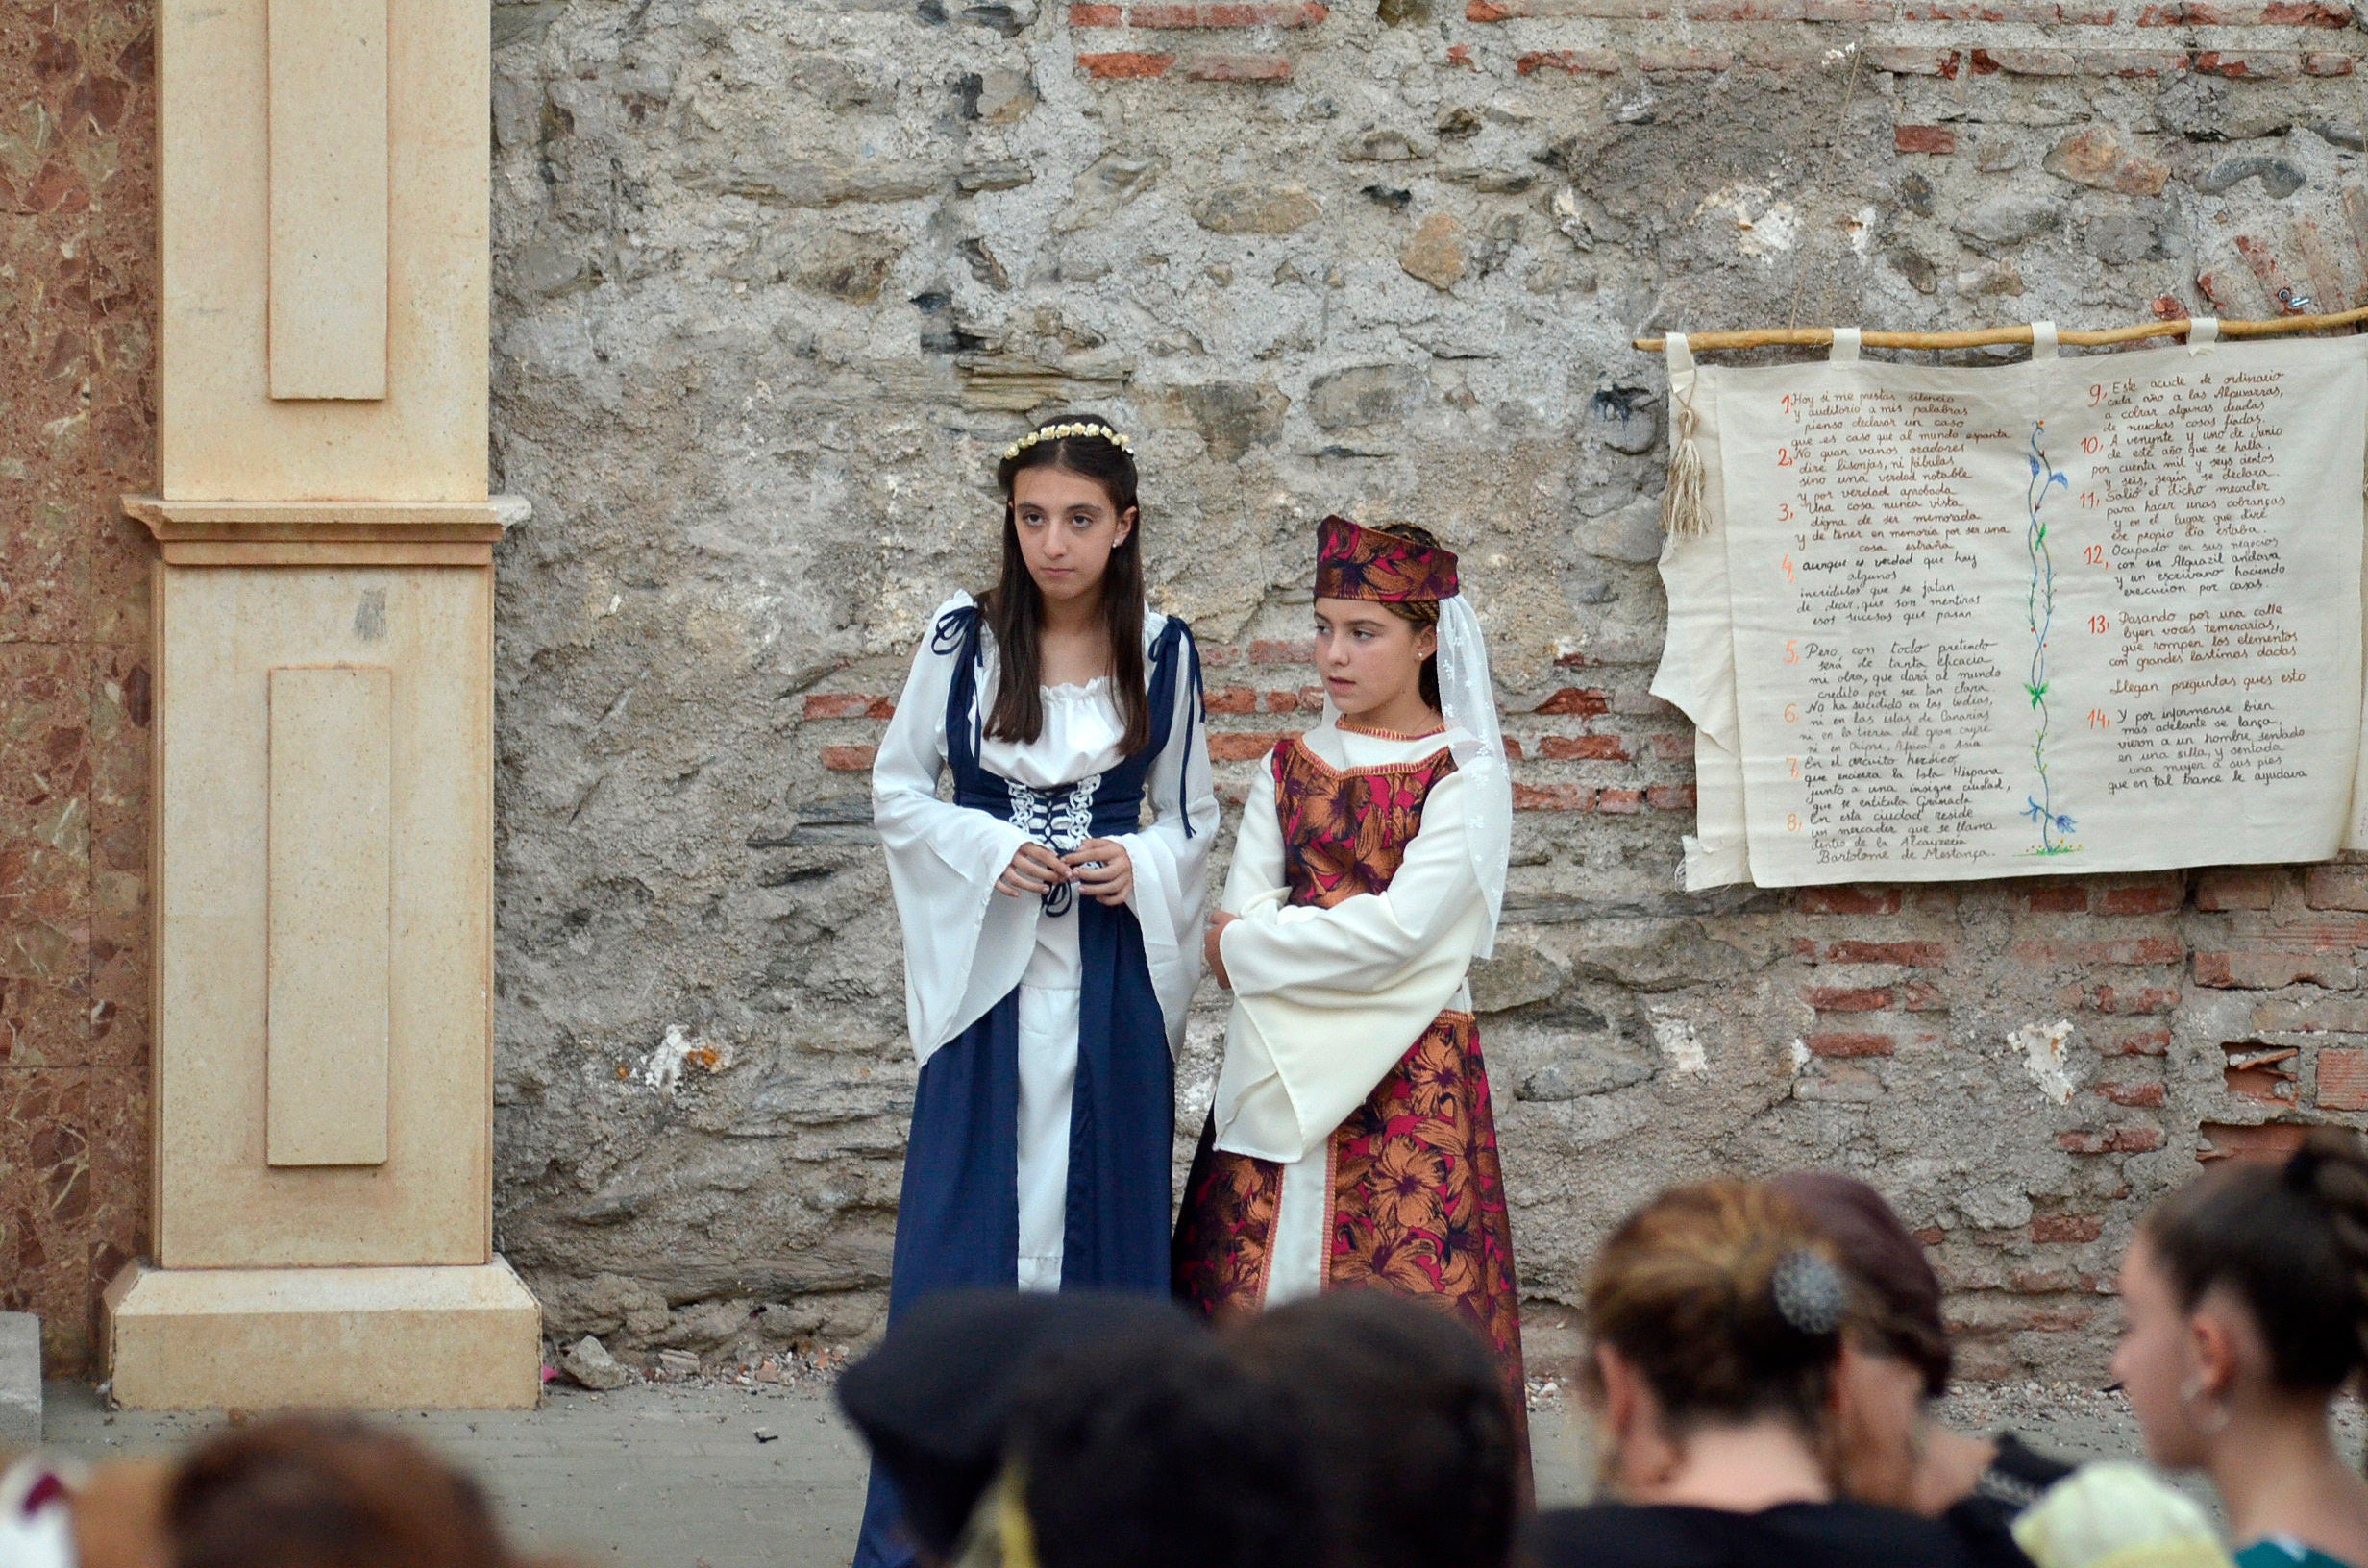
[1769,1170,1949,1507]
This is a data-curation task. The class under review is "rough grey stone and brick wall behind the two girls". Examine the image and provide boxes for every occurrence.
[493,0,2368,1376]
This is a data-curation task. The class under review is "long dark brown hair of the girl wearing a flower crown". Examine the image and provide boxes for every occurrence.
[980,414,1151,755]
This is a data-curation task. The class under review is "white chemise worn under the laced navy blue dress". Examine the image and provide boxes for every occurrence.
[872,595,1217,1291]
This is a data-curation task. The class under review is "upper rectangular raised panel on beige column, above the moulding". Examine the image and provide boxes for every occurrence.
[267,0,388,398]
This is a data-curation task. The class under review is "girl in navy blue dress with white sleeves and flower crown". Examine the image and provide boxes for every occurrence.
[855,414,1217,1568]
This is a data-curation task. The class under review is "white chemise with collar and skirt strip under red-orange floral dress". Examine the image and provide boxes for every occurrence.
[1215,720,1487,1308]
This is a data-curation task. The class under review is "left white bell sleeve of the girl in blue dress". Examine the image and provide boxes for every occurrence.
[872,595,1037,1064]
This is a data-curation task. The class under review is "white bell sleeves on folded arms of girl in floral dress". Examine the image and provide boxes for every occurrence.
[1215,774,1487,1163]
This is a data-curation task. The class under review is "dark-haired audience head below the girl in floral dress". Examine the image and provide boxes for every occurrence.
[1231,1291,1520,1568]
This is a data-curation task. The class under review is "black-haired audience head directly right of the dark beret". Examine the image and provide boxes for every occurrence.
[999,1335,1326,1568]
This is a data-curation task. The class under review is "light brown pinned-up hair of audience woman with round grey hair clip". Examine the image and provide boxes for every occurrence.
[1587,1180,1842,1440]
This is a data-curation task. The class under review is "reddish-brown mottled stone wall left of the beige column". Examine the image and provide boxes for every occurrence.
[0,0,157,1371]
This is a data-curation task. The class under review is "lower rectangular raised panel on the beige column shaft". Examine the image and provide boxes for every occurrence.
[263,663,393,1165]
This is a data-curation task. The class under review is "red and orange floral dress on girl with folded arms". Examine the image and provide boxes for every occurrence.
[1174,739,1522,1439]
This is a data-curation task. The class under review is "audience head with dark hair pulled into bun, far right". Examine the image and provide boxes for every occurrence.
[2112,1127,2368,1468]
